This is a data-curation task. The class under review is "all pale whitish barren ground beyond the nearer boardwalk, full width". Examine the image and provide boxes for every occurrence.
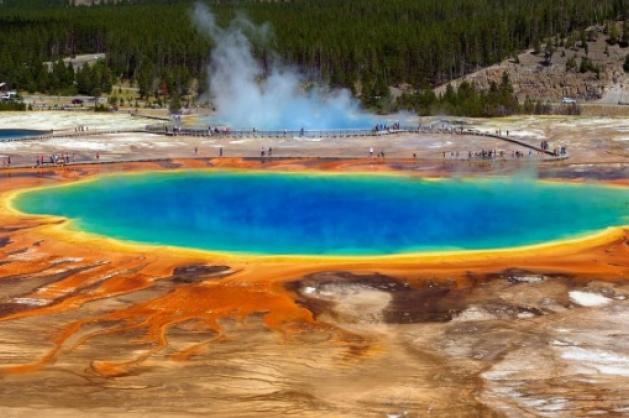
[0,112,629,165]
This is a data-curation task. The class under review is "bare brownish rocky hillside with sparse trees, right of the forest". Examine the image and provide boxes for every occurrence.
[436,23,629,104]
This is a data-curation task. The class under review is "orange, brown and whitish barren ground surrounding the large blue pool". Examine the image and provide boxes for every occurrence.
[0,113,629,418]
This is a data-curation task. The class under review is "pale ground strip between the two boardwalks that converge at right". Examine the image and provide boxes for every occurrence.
[0,124,567,167]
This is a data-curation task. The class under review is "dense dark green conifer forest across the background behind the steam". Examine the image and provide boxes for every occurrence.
[0,0,628,108]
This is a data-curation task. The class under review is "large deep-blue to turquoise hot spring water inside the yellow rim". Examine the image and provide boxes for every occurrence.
[15,171,629,255]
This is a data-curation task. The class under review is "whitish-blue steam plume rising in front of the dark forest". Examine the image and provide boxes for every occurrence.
[193,3,376,130]
